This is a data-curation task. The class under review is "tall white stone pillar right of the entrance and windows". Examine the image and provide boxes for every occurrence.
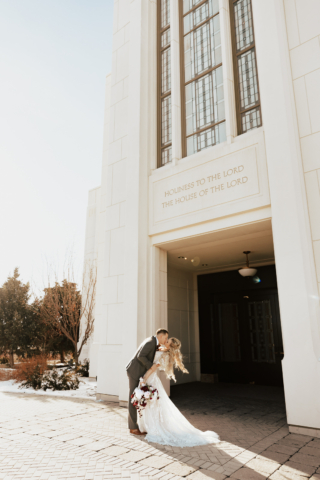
[252,0,320,436]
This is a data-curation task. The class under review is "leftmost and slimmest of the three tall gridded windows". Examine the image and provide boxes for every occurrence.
[158,0,172,166]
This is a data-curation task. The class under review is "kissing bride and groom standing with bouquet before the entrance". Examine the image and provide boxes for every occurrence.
[126,328,220,447]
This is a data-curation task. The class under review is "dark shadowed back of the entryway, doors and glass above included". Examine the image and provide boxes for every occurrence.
[198,265,284,386]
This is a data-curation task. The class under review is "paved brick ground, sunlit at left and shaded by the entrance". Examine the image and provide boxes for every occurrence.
[0,383,320,480]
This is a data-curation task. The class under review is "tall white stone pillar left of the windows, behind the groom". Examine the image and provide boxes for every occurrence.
[118,0,156,404]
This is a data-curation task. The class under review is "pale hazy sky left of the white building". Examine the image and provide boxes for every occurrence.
[0,0,113,286]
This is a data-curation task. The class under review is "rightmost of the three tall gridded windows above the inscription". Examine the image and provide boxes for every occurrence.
[230,0,262,135]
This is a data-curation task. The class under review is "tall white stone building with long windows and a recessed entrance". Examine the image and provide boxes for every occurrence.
[83,0,320,436]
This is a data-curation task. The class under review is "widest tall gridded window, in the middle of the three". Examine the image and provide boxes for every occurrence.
[181,0,226,155]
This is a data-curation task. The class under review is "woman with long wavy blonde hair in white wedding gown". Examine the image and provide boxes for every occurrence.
[138,338,220,447]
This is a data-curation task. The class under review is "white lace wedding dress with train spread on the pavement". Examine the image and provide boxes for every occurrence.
[138,351,220,447]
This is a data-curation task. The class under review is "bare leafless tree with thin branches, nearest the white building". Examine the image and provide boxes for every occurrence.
[40,263,97,366]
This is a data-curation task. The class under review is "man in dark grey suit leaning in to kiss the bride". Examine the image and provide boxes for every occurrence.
[126,328,168,435]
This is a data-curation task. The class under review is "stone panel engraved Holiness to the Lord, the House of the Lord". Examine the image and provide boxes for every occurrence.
[153,147,259,223]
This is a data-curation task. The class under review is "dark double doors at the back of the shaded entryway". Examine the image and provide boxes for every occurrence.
[210,289,283,386]
